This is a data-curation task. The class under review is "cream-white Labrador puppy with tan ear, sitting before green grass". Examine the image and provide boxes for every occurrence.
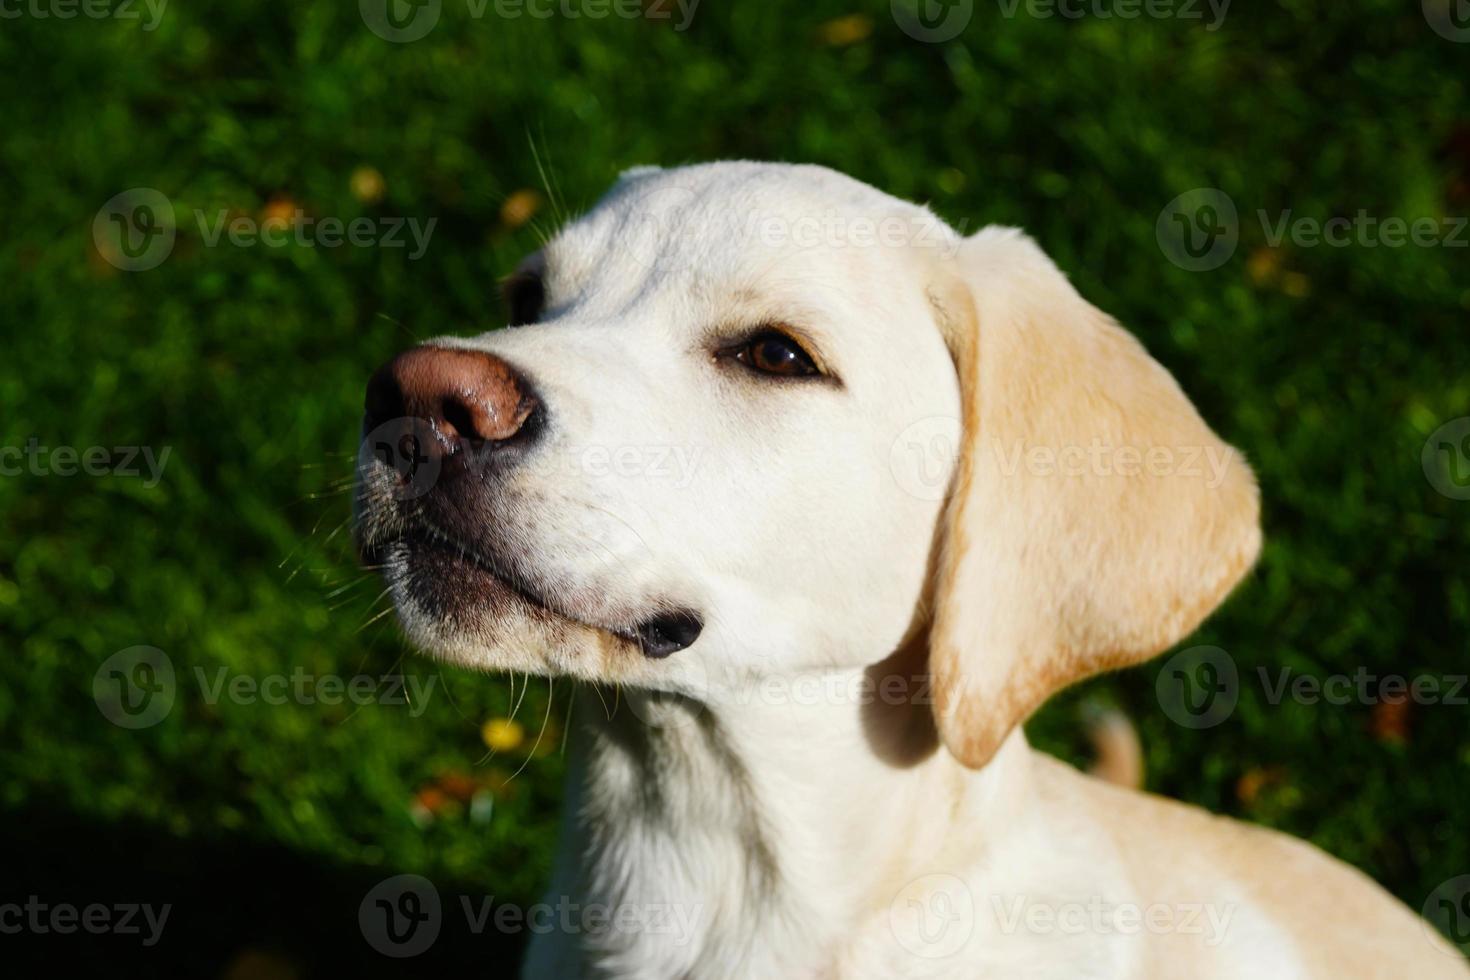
[359,163,1470,980]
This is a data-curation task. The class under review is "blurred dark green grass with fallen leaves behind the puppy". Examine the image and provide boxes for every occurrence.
[0,0,1470,977]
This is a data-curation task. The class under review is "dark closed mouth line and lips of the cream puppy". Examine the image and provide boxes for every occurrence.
[360,519,704,660]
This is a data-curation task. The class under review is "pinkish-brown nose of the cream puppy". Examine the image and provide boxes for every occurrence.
[366,347,542,455]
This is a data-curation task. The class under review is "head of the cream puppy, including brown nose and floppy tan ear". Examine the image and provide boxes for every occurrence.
[359,163,1260,765]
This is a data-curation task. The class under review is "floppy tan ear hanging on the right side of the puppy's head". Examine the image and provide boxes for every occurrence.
[929,228,1261,767]
